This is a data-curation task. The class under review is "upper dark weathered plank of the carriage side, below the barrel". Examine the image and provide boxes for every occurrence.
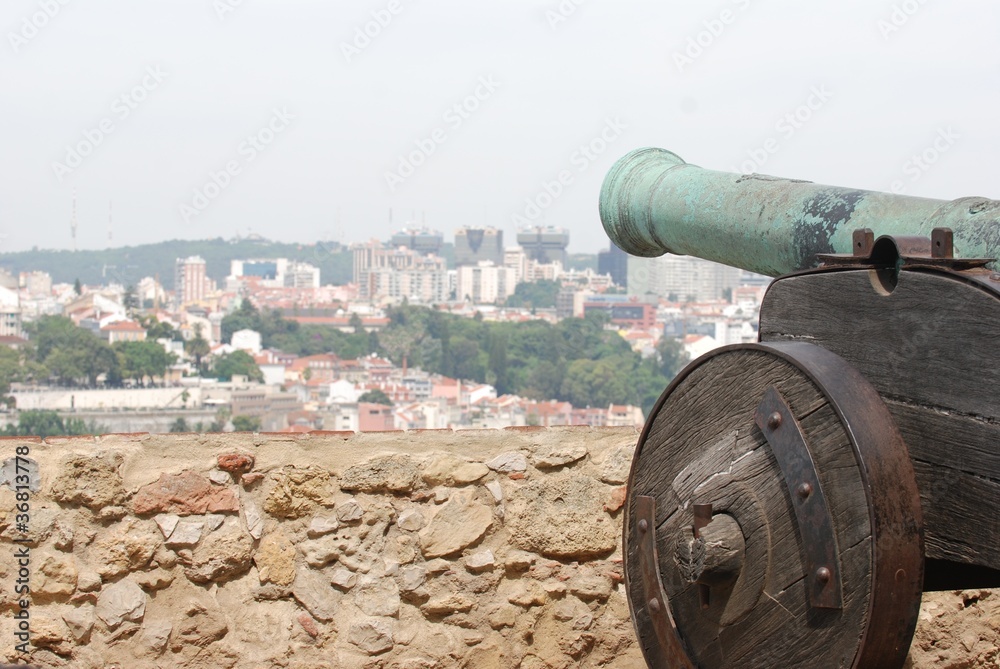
[760,270,1000,418]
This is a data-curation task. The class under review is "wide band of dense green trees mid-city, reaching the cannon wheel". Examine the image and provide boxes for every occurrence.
[222,301,687,413]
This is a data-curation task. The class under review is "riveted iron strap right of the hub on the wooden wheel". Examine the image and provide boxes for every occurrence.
[754,386,844,609]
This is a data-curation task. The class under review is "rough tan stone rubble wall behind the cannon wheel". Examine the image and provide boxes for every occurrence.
[0,428,1000,669]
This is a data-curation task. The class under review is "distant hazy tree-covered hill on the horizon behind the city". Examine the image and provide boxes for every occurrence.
[0,237,352,290]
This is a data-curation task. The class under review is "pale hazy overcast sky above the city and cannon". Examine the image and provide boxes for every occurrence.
[0,0,1000,252]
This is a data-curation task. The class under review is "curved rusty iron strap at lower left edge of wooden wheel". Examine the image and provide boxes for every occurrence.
[635,495,695,669]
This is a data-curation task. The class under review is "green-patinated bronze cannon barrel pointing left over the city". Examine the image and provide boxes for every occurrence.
[600,148,1000,276]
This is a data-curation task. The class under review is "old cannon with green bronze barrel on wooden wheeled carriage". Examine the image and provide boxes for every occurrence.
[600,149,1000,669]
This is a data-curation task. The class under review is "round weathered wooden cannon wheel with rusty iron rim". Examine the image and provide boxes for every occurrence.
[624,343,923,669]
